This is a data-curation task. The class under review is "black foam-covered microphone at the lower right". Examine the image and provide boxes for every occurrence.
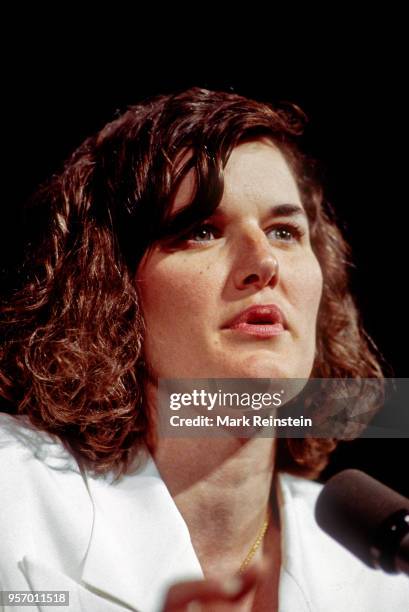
[315,470,409,575]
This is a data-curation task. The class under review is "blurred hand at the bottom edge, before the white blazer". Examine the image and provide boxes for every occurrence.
[163,563,265,612]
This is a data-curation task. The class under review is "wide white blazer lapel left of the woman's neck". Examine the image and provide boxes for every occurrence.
[82,458,203,612]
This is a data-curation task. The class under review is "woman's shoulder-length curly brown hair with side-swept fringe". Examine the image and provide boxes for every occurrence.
[0,88,382,476]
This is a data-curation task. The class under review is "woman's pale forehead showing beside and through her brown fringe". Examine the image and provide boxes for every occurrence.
[173,138,302,212]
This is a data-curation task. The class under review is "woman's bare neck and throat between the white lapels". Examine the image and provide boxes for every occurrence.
[155,437,277,575]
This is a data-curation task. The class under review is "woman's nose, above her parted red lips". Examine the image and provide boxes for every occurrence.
[233,232,279,290]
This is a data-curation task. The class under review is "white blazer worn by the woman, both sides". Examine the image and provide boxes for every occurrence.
[0,414,409,612]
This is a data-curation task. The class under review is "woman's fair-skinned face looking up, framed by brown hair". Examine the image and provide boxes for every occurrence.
[137,139,322,378]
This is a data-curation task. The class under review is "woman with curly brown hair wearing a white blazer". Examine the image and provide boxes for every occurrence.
[0,89,409,612]
